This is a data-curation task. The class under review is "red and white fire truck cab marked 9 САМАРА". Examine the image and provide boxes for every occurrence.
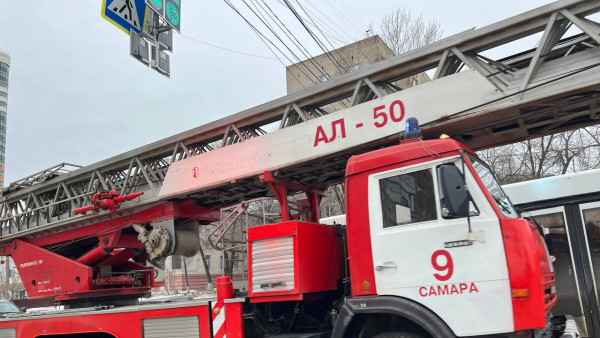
[330,139,556,337]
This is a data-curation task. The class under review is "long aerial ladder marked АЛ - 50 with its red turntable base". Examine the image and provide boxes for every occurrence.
[0,0,600,301]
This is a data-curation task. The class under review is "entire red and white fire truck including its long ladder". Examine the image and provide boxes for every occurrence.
[0,0,600,338]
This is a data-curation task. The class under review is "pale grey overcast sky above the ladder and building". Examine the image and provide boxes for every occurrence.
[0,0,549,184]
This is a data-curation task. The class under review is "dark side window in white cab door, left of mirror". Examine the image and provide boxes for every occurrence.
[379,169,437,228]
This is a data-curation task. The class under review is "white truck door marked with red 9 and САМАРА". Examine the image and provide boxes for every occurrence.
[369,158,514,336]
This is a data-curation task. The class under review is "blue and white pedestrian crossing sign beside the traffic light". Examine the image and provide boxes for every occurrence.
[102,0,146,34]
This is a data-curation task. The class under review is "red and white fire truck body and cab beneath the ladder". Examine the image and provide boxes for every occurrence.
[0,127,576,338]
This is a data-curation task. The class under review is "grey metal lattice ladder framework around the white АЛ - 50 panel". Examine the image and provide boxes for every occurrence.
[0,0,600,245]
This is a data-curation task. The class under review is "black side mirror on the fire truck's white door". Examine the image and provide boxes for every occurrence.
[437,164,469,218]
